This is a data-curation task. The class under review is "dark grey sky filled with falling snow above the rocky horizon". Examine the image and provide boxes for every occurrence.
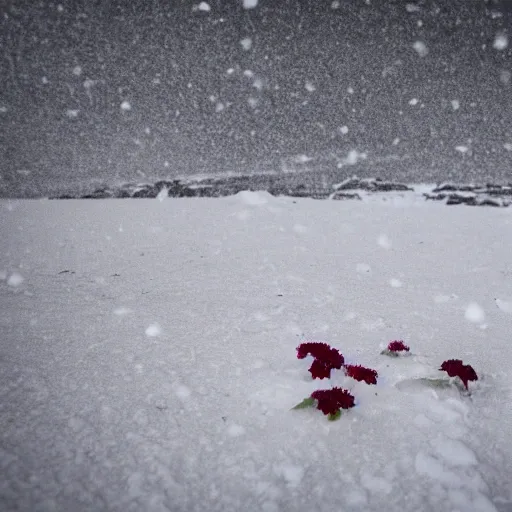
[0,0,512,196]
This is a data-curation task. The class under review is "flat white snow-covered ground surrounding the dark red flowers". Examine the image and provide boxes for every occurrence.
[0,192,512,512]
